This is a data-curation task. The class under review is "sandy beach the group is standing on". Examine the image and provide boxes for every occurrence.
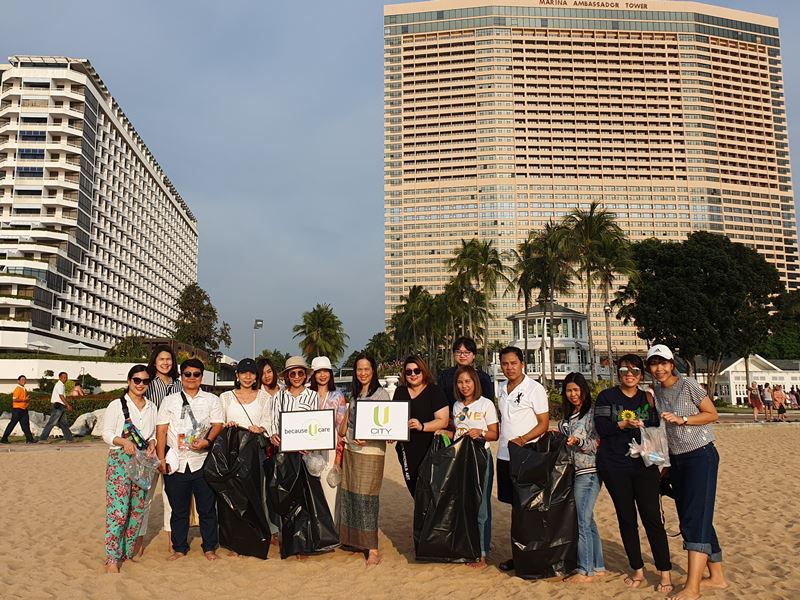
[0,424,800,600]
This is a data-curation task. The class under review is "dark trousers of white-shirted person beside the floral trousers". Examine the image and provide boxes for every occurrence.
[164,467,219,554]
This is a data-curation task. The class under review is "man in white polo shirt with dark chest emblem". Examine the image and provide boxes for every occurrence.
[497,346,550,571]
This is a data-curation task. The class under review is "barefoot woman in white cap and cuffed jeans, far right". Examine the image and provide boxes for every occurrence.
[647,344,728,600]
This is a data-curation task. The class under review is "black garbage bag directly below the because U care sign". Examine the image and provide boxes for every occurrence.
[267,452,339,558]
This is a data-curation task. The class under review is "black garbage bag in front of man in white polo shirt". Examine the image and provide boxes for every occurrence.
[508,431,578,579]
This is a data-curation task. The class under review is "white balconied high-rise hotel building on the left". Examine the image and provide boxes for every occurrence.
[0,56,197,352]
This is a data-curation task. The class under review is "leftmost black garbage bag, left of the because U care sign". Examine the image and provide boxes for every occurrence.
[203,427,271,559]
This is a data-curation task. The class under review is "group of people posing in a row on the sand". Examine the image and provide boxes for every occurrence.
[98,338,726,599]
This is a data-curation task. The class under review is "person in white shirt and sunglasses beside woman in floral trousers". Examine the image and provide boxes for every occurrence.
[156,358,224,560]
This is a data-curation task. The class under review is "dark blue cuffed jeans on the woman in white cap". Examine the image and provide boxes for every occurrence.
[669,442,722,562]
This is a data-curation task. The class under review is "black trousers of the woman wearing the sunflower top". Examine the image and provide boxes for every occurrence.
[599,463,672,571]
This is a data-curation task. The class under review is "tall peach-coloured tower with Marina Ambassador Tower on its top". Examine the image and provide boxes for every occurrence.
[384,0,800,350]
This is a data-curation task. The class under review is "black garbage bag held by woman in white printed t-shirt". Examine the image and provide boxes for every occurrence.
[414,435,488,562]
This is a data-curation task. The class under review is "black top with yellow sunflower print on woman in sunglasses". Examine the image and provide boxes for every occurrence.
[594,386,658,470]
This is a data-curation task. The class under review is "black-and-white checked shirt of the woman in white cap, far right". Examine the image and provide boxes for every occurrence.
[654,377,714,454]
